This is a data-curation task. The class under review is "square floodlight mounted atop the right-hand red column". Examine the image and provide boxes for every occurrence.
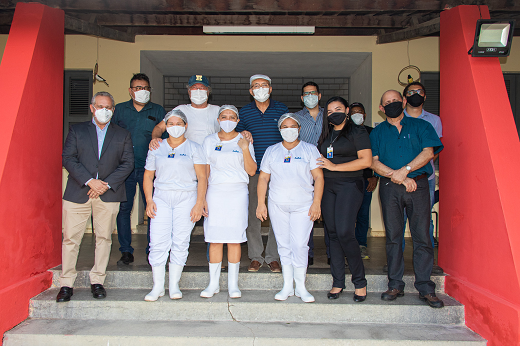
[468,19,515,57]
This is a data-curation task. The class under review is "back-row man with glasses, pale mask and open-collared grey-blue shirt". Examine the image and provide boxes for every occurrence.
[295,82,322,265]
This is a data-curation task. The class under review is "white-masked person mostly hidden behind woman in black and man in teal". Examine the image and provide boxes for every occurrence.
[350,102,379,259]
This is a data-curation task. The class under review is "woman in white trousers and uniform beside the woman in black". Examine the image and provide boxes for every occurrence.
[256,113,324,303]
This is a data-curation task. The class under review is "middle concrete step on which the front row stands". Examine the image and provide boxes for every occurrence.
[29,287,464,325]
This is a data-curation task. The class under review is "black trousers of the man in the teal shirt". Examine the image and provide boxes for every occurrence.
[379,178,435,295]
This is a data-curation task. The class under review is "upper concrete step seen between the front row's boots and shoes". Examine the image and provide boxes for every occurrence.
[52,266,444,293]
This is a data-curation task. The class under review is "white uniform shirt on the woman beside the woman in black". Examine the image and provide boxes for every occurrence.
[260,141,321,205]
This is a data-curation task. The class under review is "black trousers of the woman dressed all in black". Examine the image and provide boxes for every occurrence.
[321,177,367,288]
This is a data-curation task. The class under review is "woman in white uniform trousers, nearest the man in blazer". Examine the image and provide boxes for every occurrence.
[143,110,207,301]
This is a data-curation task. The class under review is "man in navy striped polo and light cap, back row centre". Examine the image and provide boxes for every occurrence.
[236,74,289,273]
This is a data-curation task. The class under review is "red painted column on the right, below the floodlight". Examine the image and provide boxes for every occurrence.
[439,6,520,346]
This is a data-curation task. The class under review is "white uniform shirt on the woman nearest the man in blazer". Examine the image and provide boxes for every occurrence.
[144,139,206,191]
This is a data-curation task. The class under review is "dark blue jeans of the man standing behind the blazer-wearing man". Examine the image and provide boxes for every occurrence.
[116,168,150,254]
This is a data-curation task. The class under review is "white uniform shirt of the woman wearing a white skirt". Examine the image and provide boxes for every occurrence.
[205,133,256,185]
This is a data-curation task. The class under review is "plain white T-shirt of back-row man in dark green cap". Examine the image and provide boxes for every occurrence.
[175,105,220,145]
